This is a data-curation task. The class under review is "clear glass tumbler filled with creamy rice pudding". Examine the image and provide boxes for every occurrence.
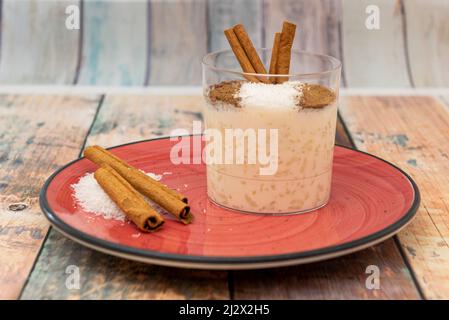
[203,49,341,215]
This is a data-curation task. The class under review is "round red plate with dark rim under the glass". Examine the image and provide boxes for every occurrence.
[40,137,420,269]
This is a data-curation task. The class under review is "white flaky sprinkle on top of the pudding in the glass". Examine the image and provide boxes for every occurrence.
[236,81,302,108]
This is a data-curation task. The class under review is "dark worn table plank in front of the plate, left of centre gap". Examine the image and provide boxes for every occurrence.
[21,229,229,300]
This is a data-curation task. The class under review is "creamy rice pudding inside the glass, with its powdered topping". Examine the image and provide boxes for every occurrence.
[205,81,337,214]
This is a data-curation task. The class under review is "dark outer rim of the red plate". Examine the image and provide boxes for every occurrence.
[39,134,421,269]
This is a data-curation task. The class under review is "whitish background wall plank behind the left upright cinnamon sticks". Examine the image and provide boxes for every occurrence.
[207,0,264,51]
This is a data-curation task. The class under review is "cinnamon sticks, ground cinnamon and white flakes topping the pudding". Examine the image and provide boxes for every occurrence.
[206,21,335,110]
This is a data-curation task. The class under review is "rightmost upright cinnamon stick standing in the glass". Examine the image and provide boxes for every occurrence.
[276,21,296,83]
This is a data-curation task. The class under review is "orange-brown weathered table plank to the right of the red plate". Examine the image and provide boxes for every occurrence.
[340,96,449,299]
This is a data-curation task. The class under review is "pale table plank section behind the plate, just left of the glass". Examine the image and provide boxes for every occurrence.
[87,95,203,147]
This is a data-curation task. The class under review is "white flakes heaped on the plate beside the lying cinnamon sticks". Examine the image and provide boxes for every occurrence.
[71,173,161,221]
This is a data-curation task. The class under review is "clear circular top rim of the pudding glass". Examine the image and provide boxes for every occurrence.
[201,48,342,78]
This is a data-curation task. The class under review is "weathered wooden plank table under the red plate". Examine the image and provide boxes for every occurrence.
[0,89,449,299]
